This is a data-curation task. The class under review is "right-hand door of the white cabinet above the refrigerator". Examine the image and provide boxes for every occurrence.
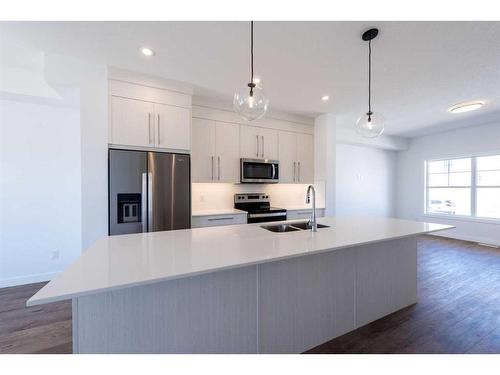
[154,104,191,150]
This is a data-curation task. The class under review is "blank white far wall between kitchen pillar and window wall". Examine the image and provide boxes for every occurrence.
[336,143,396,217]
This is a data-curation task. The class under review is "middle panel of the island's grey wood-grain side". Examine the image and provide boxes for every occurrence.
[259,249,356,353]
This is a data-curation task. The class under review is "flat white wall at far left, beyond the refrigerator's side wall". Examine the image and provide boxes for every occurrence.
[0,100,81,287]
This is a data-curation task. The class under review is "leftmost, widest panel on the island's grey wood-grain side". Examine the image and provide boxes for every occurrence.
[74,266,257,353]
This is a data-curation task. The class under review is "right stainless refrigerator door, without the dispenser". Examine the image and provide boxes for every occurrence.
[148,152,191,232]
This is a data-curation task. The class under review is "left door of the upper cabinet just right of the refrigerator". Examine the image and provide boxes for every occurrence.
[191,118,216,182]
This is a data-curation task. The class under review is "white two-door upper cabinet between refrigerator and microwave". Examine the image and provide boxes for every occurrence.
[191,118,240,183]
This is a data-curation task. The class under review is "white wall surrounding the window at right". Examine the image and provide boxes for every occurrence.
[397,124,500,244]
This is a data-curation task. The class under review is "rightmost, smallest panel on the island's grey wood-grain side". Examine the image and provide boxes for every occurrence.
[356,236,417,327]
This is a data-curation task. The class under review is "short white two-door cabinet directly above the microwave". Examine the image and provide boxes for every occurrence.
[240,125,278,160]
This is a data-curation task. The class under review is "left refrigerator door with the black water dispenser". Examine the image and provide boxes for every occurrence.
[108,150,147,235]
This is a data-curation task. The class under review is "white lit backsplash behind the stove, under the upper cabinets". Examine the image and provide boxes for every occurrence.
[192,181,325,211]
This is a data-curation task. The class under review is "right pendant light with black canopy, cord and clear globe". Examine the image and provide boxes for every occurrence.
[356,29,384,138]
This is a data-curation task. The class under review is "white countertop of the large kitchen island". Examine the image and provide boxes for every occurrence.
[28,217,453,305]
